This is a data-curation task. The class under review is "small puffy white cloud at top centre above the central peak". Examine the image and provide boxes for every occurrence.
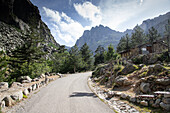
[74,2,102,26]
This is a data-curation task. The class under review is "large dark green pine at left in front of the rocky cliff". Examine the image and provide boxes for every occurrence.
[9,33,45,78]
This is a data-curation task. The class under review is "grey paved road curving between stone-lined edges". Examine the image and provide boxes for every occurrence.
[16,72,114,113]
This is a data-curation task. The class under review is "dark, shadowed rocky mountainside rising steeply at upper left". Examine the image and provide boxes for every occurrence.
[0,0,60,56]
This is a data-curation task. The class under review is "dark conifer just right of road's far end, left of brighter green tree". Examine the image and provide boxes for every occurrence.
[94,45,105,65]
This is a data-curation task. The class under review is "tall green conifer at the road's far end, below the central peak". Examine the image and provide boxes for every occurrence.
[80,43,93,71]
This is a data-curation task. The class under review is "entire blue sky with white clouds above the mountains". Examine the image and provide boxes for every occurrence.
[31,0,170,47]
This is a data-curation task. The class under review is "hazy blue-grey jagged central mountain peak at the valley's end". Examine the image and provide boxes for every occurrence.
[76,25,129,52]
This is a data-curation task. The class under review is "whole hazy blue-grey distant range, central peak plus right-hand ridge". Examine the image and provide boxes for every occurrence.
[76,12,170,52]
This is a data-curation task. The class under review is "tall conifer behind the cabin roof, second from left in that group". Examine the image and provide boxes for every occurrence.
[131,25,146,47]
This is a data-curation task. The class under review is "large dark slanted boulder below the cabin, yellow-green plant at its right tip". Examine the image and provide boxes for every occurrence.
[121,64,138,75]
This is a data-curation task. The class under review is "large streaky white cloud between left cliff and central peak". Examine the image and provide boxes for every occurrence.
[43,7,85,46]
